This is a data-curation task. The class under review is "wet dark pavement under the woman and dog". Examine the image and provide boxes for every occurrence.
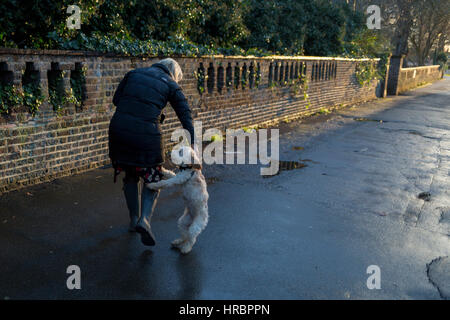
[0,79,450,299]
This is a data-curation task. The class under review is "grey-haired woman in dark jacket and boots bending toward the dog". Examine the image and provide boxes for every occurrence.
[109,58,194,246]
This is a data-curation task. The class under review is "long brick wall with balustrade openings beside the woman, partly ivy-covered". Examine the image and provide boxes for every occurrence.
[0,49,378,193]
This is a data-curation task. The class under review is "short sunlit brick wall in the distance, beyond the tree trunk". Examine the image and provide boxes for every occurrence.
[398,65,442,93]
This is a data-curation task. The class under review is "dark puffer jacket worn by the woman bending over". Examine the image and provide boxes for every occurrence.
[109,63,194,167]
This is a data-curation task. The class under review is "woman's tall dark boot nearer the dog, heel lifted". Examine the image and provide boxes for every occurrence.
[136,187,159,246]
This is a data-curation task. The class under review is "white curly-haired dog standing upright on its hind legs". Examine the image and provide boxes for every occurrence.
[146,147,209,254]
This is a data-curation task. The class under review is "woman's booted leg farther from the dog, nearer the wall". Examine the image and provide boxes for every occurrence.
[123,168,139,232]
